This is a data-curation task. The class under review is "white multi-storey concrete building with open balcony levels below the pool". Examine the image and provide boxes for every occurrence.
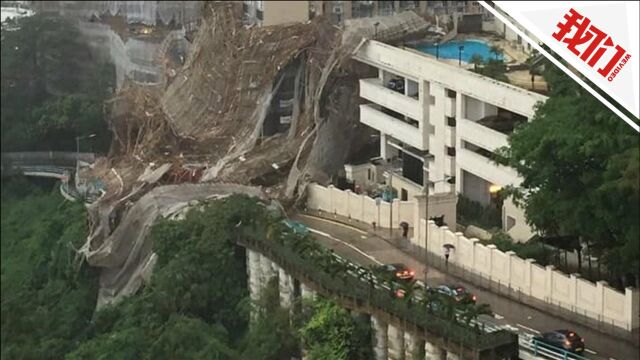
[345,41,546,241]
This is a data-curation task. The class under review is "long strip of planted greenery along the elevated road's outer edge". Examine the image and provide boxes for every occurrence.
[248,221,518,358]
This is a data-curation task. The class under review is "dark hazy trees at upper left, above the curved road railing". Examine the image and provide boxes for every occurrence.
[1,15,115,151]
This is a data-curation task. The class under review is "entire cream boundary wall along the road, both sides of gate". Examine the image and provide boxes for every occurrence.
[307,184,640,330]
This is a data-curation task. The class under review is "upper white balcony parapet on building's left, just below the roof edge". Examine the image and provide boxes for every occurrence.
[360,78,422,121]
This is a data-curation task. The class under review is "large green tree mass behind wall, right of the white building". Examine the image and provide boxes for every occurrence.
[498,62,640,286]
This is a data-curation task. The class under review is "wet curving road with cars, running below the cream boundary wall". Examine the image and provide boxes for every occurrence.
[292,214,640,360]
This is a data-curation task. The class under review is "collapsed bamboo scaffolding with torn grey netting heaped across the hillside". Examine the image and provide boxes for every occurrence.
[78,2,438,307]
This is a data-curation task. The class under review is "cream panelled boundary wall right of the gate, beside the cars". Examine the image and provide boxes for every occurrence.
[412,219,640,330]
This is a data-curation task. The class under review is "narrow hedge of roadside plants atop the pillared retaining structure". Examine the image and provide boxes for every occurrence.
[241,225,517,358]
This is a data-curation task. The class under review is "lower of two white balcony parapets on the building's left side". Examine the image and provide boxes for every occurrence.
[360,105,429,150]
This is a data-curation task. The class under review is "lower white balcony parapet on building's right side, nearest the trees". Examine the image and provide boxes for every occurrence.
[456,149,522,186]
